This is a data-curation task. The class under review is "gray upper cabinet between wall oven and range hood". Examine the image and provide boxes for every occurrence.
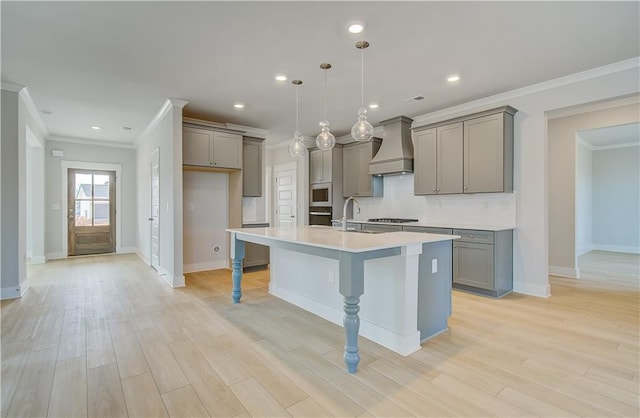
[342,138,382,197]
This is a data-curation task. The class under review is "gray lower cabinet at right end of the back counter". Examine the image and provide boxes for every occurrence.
[453,229,513,297]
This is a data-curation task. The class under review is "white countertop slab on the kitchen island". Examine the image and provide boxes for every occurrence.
[227,225,460,253]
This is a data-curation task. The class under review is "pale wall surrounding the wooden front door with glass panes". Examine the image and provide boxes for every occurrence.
[45,140,137,258]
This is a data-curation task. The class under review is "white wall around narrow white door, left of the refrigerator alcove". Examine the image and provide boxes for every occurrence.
[136,99,186,287]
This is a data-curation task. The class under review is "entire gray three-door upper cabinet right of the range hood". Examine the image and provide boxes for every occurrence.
[414,106,517,195]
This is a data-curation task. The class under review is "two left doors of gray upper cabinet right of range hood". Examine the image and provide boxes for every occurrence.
[413,122,463,195]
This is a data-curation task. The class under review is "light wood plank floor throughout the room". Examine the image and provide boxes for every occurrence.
[1,255,640,417]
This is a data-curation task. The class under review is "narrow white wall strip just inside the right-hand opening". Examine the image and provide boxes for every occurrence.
[575,140,593,256]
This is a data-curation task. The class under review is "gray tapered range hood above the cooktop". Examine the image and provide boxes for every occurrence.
[369,116,413,175]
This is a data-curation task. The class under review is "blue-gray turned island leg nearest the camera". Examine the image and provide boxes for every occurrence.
[339,253,364,373]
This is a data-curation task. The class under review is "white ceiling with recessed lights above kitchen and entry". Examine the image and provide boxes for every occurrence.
[0,1,640,143]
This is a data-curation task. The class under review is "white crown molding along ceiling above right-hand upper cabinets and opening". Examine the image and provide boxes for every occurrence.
[411,57,640,129]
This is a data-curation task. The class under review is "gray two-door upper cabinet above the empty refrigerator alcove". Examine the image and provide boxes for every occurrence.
[182,126,242,169]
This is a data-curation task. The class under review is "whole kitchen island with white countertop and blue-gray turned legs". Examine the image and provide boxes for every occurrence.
[227,226,457,373]
